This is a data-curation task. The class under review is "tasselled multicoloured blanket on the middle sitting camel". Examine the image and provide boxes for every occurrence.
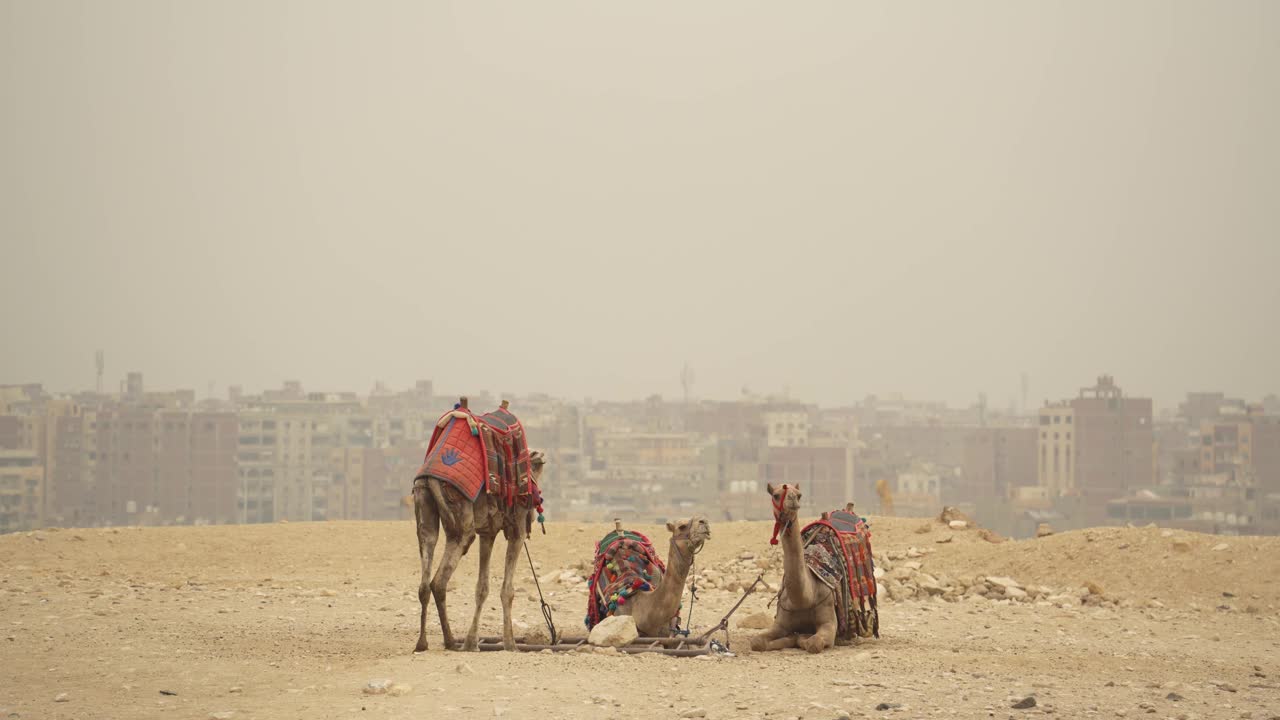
[585,530,667,629]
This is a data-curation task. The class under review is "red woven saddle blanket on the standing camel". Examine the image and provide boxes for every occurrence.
[413,407,541,506]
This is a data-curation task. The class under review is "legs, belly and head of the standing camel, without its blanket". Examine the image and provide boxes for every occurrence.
[413,451,545,652]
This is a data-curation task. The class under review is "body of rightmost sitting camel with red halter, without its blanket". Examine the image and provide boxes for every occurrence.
[751,483,837,653]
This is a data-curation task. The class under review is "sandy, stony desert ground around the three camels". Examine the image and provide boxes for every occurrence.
[0,519,1280,720]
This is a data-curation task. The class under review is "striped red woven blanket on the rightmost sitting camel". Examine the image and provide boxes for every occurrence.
[800,510,879,639]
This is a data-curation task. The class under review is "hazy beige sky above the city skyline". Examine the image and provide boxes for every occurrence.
[0,0,1280,406]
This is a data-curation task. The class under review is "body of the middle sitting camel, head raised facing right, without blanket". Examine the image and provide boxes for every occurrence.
[588,515,712,638]
